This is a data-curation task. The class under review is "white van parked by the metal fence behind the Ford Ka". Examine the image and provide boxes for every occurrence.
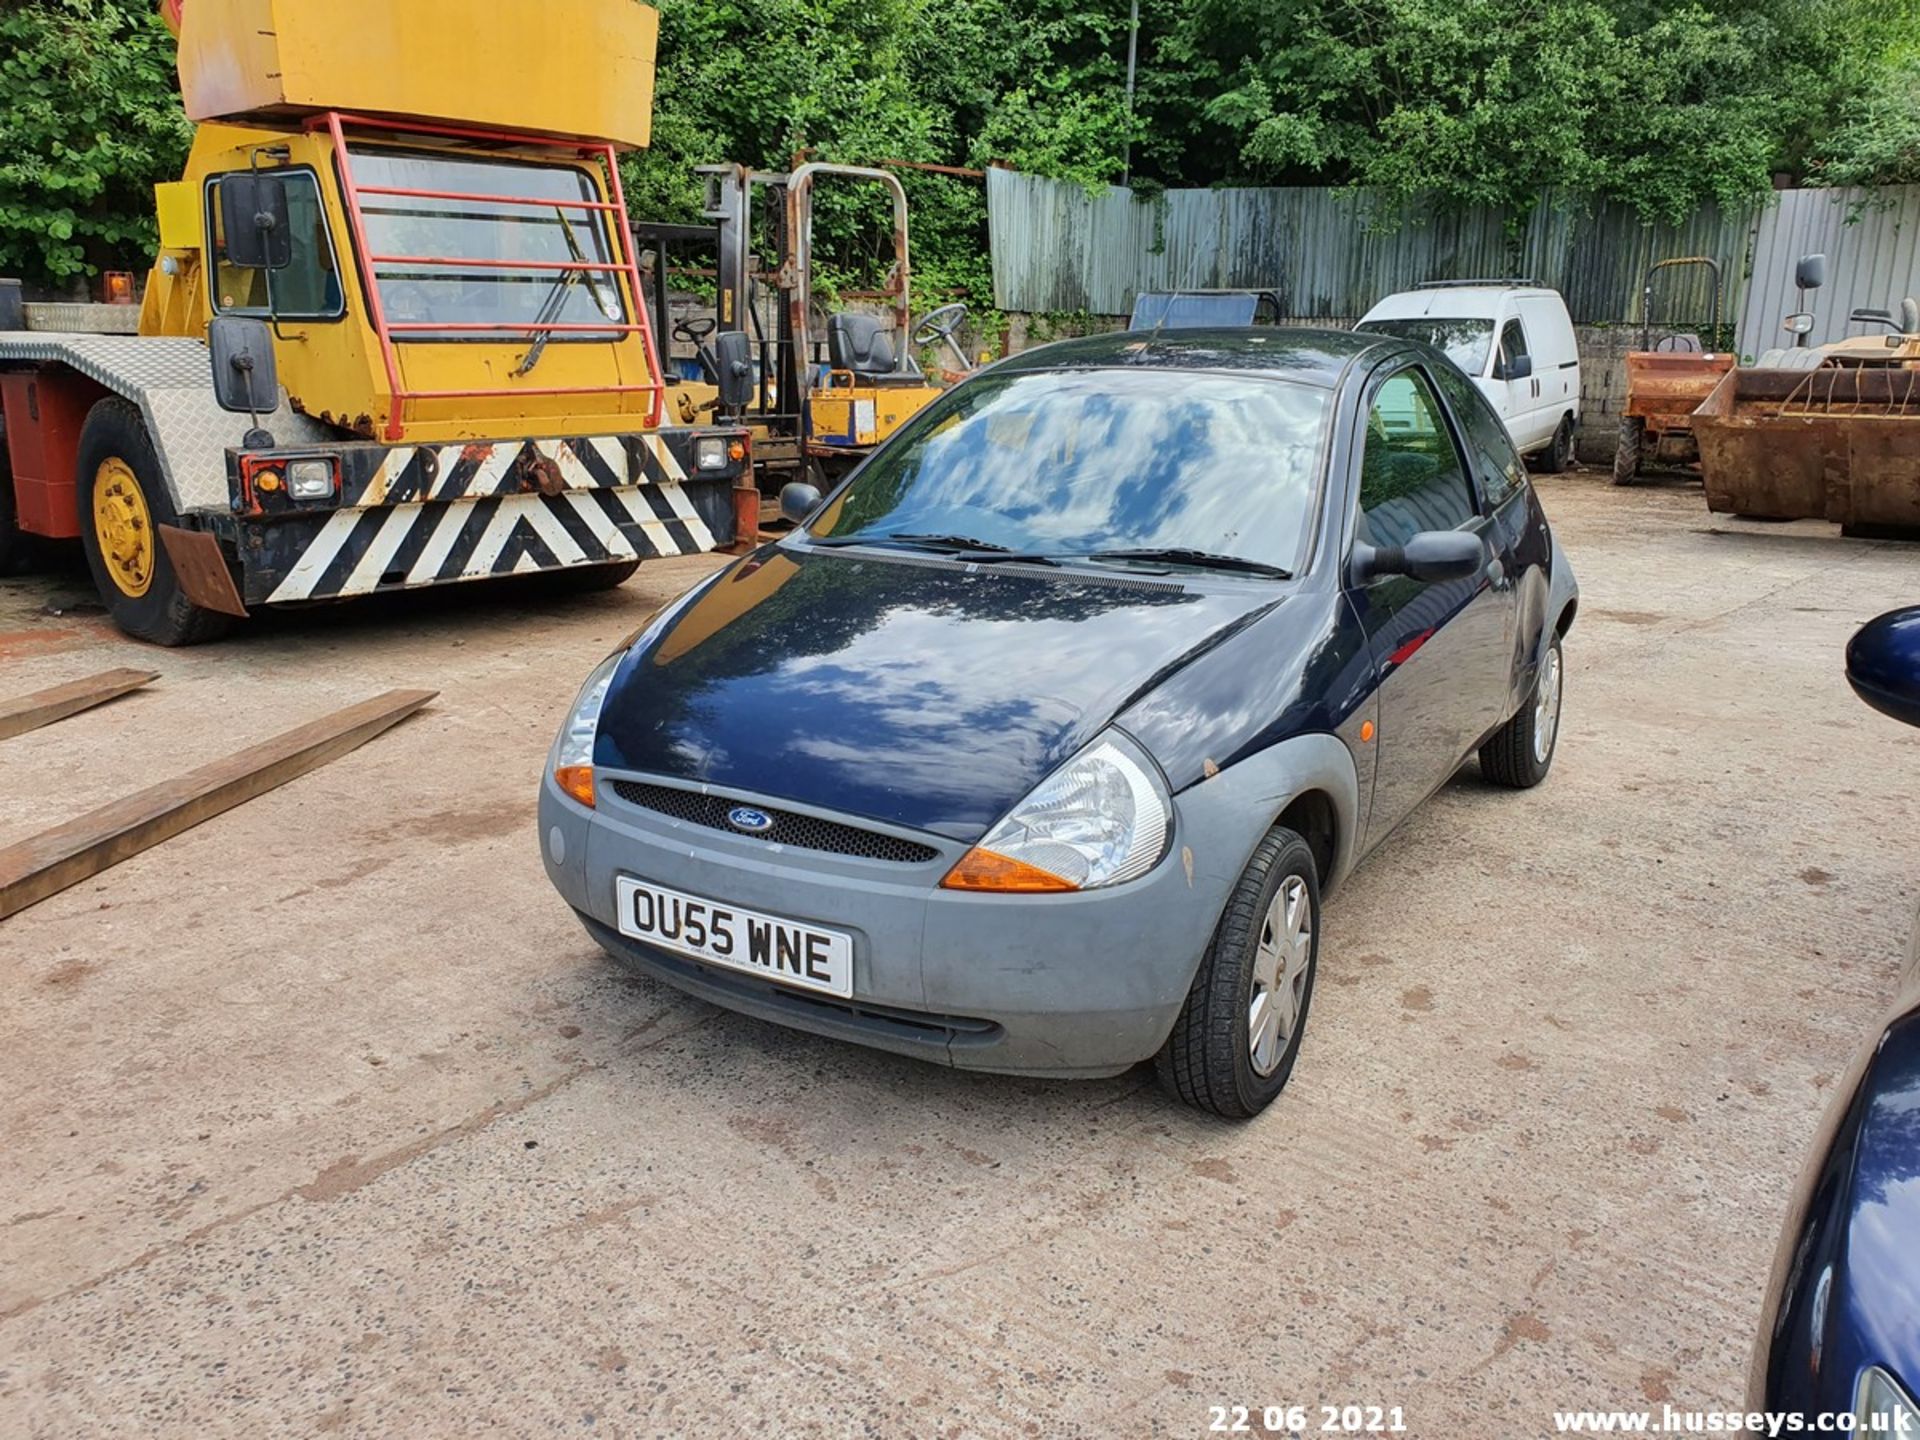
[1356,280,1580,470]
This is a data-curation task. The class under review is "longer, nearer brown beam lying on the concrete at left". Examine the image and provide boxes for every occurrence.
[0,689,440,920]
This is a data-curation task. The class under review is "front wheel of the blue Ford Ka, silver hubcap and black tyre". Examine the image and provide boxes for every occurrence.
[1154,826,1319,1119]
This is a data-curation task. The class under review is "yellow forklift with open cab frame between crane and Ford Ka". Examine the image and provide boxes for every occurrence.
[672,161,973,492]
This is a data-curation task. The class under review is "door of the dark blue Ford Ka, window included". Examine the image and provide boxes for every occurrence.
[1348,363,1507,843]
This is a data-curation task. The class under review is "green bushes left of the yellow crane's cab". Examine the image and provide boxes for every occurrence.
[0,0,192,284]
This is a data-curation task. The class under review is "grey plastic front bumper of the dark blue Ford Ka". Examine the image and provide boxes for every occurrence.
[540,778,1267,1075]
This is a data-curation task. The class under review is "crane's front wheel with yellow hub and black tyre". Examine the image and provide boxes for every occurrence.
[75,396,232,645]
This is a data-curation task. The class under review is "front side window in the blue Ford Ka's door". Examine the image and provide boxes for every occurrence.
[1356,367,1476,545]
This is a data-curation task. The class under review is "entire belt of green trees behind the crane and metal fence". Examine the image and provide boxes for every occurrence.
[0,0,1920,299]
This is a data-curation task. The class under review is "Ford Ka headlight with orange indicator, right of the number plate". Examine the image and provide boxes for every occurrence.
[941,732,1173,893]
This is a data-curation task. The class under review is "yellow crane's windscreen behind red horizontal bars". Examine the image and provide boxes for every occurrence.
[351,148,626,344]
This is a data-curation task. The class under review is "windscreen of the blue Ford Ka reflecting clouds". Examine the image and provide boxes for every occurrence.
[808,369,1331,570]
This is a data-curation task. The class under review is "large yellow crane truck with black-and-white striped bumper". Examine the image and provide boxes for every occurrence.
[0,0,753,645]
